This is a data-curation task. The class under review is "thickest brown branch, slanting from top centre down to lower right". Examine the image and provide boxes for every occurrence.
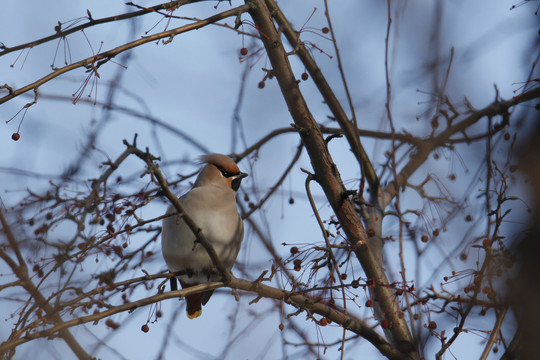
[246,0,418,358]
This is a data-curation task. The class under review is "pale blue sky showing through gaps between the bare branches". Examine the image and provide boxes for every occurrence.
[0,0,538,359]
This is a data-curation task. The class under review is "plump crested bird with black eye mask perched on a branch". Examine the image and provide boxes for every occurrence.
[161,153,248,319]
